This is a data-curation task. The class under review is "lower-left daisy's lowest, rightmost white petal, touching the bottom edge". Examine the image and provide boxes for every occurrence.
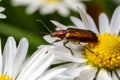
[38,68,66,80]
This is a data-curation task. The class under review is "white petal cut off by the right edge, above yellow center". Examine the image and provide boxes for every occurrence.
[110,6,120,35]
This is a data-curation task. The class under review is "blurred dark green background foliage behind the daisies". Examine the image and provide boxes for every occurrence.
[0,0,118,54]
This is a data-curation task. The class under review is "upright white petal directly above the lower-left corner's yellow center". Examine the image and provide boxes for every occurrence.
[3,37,16,75]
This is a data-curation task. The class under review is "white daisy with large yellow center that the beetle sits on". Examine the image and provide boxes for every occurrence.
[44,6,120,80]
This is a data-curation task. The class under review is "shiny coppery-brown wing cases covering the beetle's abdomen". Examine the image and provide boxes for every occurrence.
[65,28,98,43]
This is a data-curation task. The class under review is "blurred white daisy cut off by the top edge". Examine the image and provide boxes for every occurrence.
[12,0,85,16]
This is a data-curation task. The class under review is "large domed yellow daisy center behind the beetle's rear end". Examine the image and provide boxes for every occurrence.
[85,33,120,69]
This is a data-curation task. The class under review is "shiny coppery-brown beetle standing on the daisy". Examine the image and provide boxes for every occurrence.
[51,28,98,55]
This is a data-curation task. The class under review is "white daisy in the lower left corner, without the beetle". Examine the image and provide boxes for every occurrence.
[0,37,66,80]
